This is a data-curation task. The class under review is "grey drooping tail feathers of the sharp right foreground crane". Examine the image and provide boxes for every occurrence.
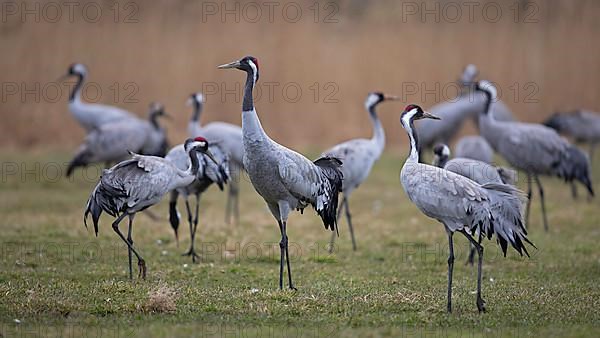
[472,183,535,257]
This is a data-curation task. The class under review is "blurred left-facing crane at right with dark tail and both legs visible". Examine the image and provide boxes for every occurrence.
[476,81,594,230]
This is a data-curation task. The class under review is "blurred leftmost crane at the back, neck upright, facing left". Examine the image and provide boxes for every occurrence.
[63,63,137,132]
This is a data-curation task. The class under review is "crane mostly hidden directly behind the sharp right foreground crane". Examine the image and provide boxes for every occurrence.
[432,143,516,265]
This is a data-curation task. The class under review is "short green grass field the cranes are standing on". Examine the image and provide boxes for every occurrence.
[0,150,600,337]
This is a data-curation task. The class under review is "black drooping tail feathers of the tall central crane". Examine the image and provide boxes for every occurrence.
[313,156,344,231]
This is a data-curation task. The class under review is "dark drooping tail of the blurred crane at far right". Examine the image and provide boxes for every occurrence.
[553,145,594,196]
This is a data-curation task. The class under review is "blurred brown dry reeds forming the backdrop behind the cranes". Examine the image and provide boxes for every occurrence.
[0,0,600,149]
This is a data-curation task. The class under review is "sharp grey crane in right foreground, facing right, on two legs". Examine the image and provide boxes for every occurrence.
[400,105,533,312]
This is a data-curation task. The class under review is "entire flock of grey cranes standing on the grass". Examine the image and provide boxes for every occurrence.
[64,56,600,312]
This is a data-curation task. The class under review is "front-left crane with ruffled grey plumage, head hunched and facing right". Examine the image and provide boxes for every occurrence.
[83,137,216,279]
